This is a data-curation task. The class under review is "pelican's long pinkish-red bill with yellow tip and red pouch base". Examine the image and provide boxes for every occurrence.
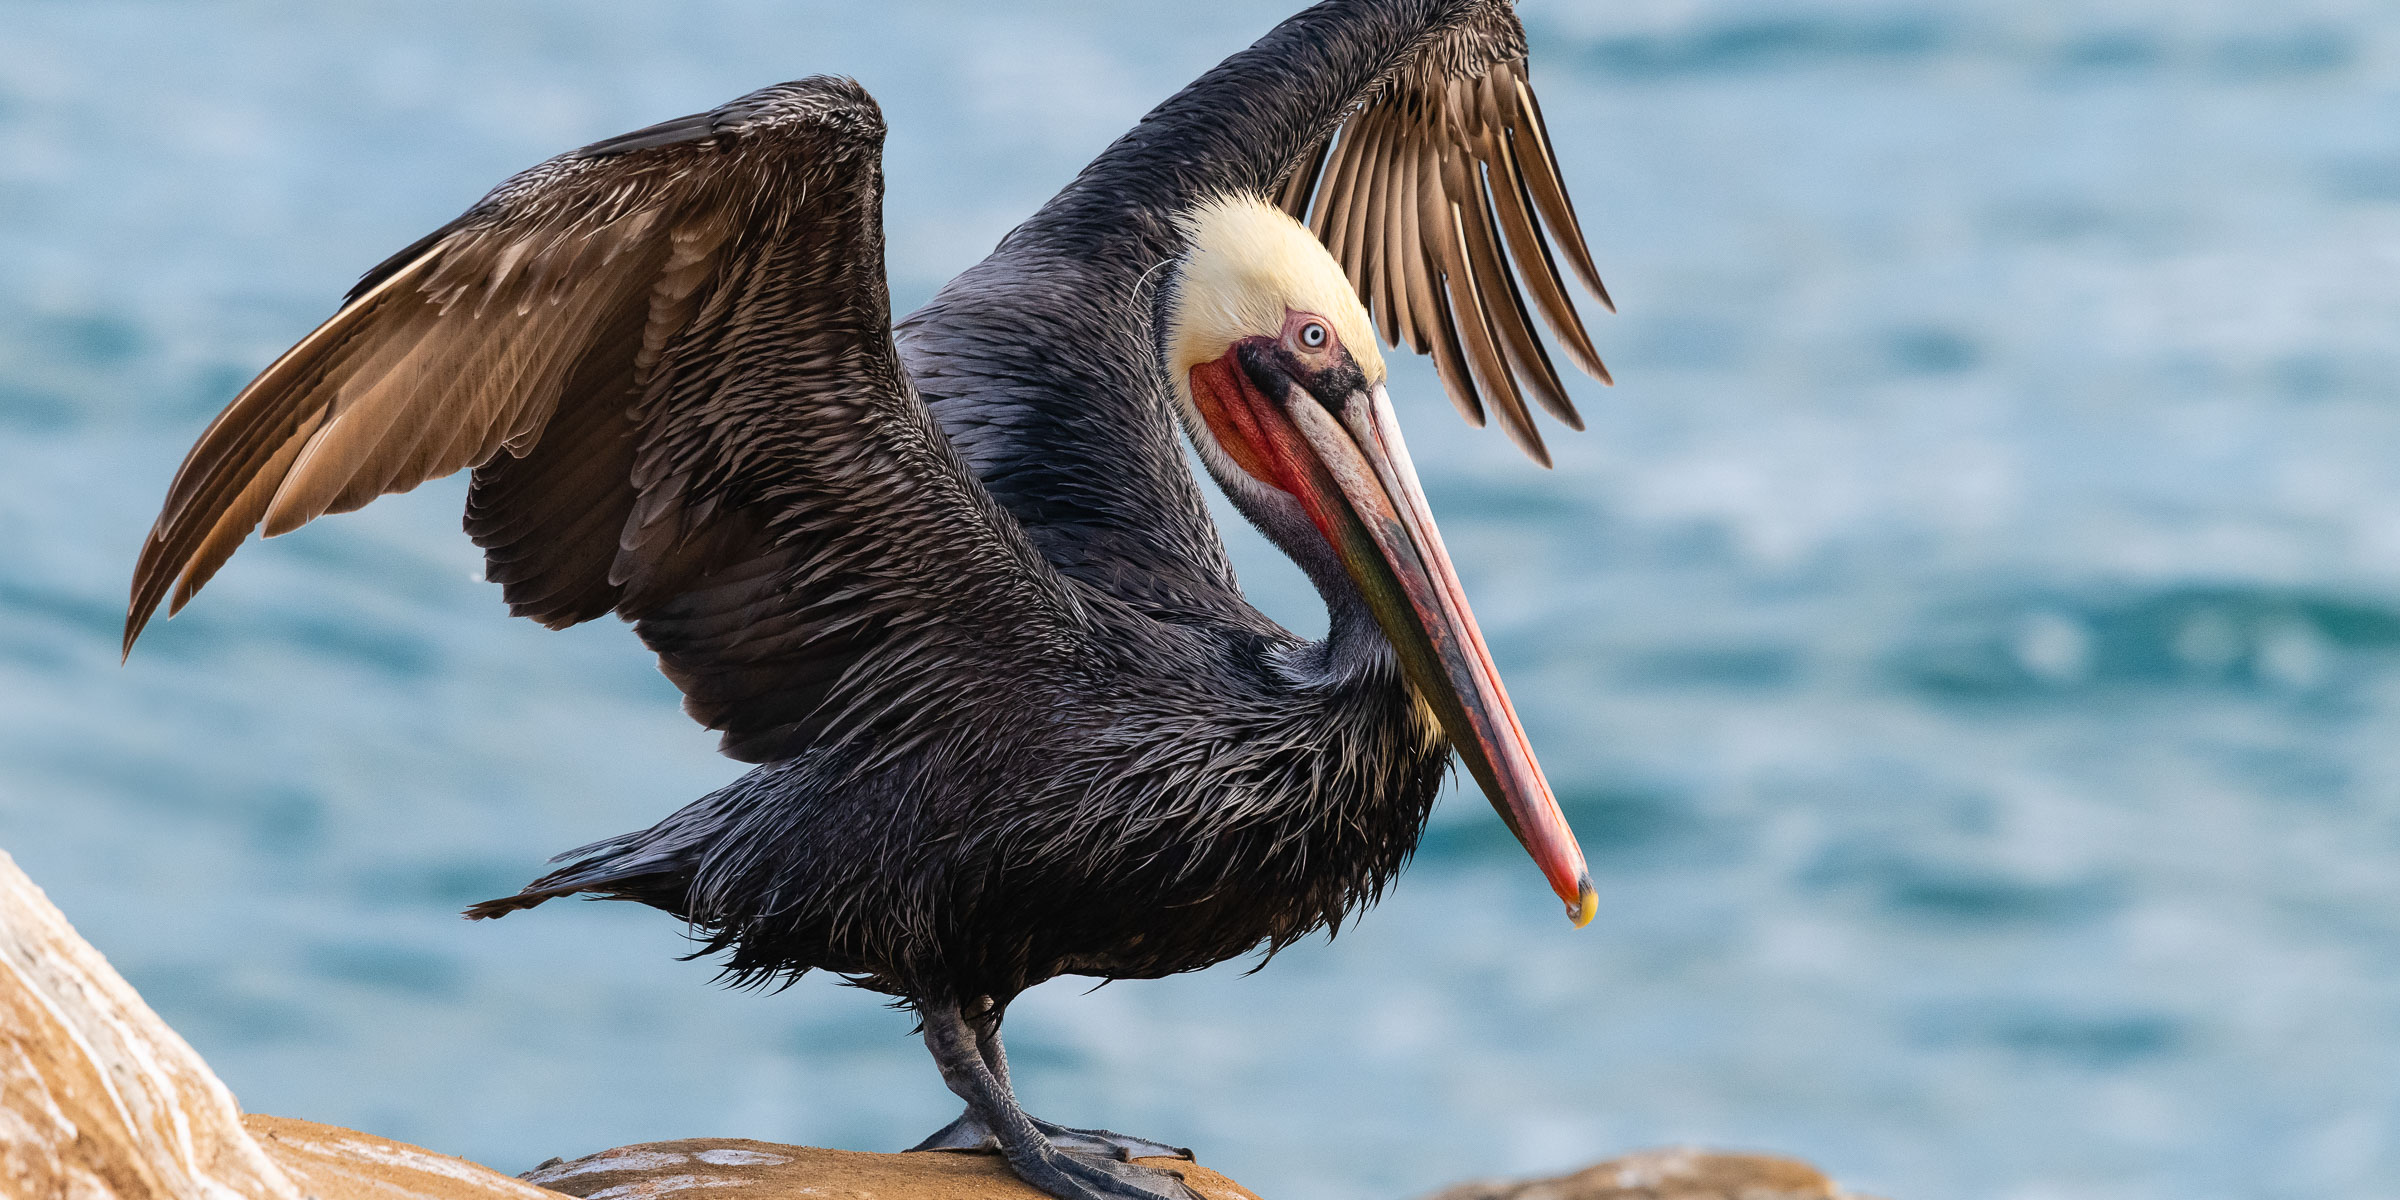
[1193,355,1598,929]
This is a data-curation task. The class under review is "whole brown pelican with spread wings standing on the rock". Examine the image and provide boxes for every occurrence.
[125,0,1606,1198]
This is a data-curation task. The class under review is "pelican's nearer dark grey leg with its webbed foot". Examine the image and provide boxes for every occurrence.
[917,1001,1202,1200]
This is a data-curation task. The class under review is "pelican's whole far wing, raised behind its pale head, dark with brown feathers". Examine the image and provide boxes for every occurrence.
[900,0,1606,624]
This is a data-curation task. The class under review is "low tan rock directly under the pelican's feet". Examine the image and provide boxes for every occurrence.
[526,1138,1258,1200]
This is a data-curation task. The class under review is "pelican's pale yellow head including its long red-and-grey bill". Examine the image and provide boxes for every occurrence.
[1164,197,1598,926]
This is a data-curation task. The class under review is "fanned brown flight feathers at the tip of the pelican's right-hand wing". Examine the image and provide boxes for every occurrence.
[1277,32,1615,466]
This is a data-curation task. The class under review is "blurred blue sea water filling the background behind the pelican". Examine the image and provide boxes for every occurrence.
[0,0,2400,1200]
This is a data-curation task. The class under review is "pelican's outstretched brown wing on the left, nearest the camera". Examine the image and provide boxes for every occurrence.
[125,79,1080,761]
